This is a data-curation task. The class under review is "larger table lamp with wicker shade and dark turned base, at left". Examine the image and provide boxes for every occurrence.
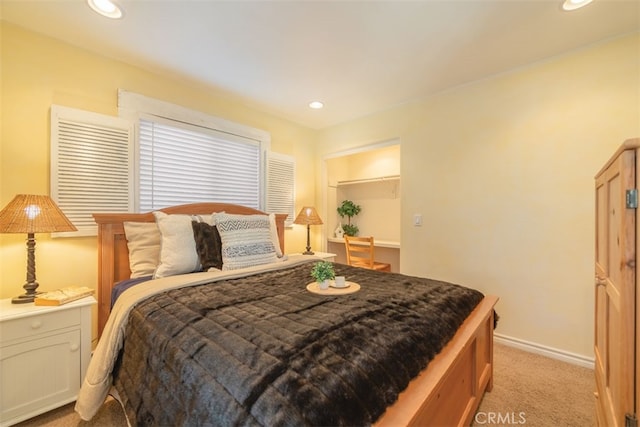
[0,194,77,304]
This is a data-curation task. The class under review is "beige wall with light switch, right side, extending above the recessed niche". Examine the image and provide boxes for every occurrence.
[318,34,640,358]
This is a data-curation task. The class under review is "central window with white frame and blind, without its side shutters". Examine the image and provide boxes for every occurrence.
[118,90,274,211]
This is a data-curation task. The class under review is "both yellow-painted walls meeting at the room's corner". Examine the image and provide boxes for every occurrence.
[0,23,640,357]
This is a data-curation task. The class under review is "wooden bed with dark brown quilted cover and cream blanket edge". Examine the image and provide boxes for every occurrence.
[76,203,497,426]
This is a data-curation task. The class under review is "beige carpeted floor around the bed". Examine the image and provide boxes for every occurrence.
[18,344,596,427]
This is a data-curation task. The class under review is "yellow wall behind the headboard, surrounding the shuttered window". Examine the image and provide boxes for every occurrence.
[0,22,316,320]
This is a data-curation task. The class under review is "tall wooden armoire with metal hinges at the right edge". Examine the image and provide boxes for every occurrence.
[594,138,640,427]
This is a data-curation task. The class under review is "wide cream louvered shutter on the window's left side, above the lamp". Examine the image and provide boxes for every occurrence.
[51,105,134,236]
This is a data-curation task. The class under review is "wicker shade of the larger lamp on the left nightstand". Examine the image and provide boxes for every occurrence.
[0,194,77,233]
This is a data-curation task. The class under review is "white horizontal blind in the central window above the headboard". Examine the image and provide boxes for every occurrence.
[139,117,263,211]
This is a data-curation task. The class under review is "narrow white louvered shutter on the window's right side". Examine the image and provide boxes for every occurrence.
[267,153,295,227]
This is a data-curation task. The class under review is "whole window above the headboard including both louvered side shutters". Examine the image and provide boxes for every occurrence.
[51,91,295,235]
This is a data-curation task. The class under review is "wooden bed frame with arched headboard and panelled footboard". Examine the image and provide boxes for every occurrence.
[93,203,498,427]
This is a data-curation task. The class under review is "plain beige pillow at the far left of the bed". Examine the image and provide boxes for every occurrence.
[123,221,160,279]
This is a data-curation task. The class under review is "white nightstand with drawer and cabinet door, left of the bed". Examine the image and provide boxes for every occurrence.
[0,296,96,426]
